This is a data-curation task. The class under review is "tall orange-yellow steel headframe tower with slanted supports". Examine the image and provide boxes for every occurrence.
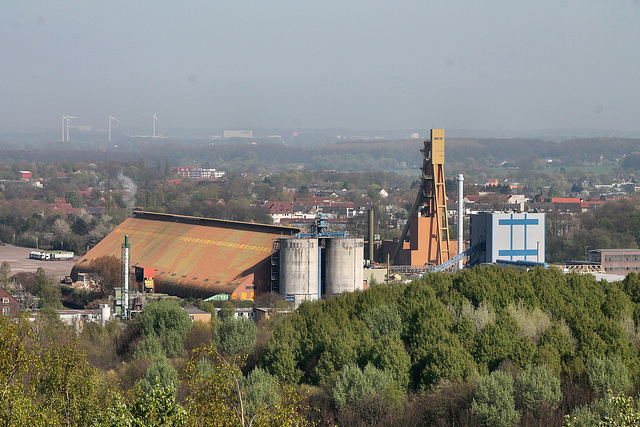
[393,129,452,265]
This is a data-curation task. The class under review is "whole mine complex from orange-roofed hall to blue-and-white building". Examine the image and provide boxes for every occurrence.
[72,129,545,314]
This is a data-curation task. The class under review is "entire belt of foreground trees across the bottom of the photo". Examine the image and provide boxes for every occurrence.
[0,267,640,426]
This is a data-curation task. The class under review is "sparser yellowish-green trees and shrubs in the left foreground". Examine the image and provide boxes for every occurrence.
[0,300,310,427]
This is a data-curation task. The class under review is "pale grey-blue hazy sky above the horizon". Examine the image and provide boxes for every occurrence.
[0,0,640,132]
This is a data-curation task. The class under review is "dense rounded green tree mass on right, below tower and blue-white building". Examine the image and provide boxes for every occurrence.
[255,267,640,425]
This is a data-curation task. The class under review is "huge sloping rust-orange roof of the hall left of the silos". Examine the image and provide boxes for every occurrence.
[72,212,300,297]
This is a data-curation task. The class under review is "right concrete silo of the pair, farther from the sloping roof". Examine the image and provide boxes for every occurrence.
[324,237,364,297]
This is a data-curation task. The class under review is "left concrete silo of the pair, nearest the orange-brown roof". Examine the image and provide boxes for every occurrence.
[280,238,319,306]
